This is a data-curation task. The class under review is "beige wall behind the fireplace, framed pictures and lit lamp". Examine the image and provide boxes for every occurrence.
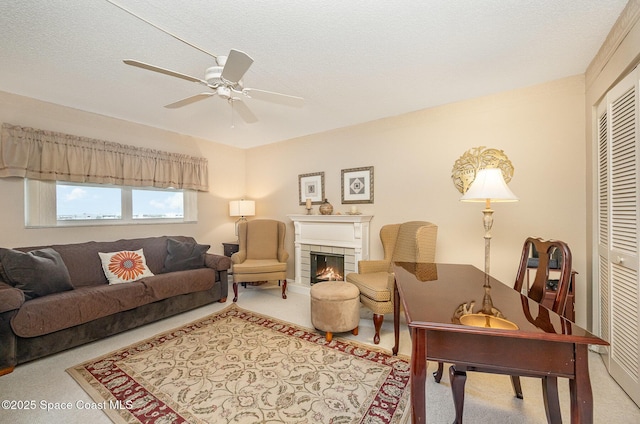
[246,76,587,323]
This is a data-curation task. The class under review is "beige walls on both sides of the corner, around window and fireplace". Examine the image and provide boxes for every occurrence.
[0,76,587,323]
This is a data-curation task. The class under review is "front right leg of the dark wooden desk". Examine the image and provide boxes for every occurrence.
[569,344,593,424]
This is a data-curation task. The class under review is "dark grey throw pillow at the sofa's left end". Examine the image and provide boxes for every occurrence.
[0,248,73,300]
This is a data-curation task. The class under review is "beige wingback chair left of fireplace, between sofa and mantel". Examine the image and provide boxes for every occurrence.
[231,219,289,302]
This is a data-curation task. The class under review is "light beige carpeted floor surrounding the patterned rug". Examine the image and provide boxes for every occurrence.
[0,280,640,424]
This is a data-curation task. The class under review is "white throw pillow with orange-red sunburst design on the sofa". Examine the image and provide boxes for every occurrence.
[98,249,153,284]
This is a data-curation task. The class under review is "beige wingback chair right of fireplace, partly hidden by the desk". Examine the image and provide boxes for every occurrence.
[347,221,438,344]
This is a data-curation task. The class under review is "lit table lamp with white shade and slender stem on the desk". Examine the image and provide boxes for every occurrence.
[460,168,518,275]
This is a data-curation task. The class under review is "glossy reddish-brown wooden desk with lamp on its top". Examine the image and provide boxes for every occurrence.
[393,263,607,424]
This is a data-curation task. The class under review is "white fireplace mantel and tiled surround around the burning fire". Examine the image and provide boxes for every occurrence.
[288,215,373,287]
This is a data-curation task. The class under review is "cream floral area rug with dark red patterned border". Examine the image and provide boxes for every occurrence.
[67,304,410,424]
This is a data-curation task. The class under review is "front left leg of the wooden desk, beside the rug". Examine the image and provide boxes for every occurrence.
[411,328,427,424]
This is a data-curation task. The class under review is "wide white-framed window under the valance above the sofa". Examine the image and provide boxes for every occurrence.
[25,180,197,227]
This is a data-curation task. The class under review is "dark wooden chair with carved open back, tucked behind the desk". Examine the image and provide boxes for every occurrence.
[434,237,571,423]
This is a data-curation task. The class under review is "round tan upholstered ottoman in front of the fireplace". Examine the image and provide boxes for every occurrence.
[311,281,360,342]
